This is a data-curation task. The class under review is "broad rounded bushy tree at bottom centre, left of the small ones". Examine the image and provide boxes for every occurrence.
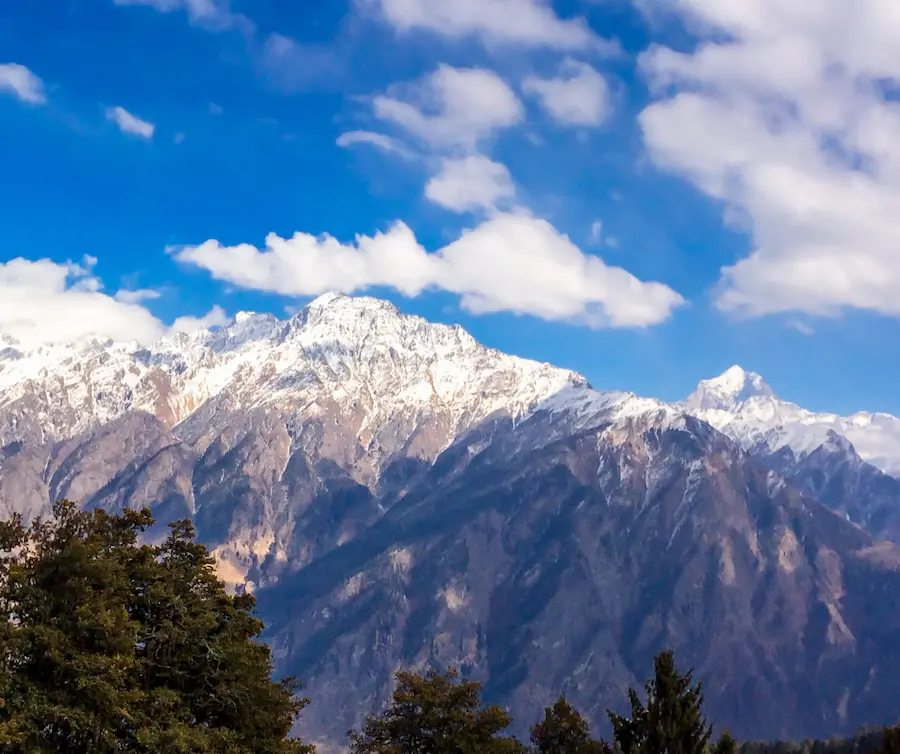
[350,669,524,754]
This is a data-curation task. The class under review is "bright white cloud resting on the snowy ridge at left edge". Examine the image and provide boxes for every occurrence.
[0,257,224,347]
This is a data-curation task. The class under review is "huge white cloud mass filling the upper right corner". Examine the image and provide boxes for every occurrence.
[640,0,900,315]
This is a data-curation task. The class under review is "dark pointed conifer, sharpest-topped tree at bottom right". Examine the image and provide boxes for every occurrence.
[607,651,712,754]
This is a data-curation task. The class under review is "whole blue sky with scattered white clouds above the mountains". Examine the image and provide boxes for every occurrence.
[0,0,900,414]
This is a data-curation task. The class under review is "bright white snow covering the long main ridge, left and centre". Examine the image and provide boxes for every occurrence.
[0,294,586,450]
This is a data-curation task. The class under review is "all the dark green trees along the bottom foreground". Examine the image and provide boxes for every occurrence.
[0,501,900,754]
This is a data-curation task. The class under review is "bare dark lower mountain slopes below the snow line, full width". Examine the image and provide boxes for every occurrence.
[0,396,900,743]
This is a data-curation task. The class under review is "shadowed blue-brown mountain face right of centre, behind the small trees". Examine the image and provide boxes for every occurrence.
[243,406,900,740]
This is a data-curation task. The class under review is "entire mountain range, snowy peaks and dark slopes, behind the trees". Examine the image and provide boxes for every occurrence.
[0,294,900,744]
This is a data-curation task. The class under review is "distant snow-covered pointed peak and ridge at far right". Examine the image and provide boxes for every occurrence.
[684,366,900,477]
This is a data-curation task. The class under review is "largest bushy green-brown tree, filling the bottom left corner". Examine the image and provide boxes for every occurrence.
[0,501,311,754]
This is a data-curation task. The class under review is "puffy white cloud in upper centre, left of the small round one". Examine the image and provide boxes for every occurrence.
[373,65,524,150]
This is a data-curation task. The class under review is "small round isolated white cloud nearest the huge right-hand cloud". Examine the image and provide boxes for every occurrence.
[522,60,610,126]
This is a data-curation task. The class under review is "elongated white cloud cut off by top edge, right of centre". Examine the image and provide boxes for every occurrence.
[360,0,618,53]
